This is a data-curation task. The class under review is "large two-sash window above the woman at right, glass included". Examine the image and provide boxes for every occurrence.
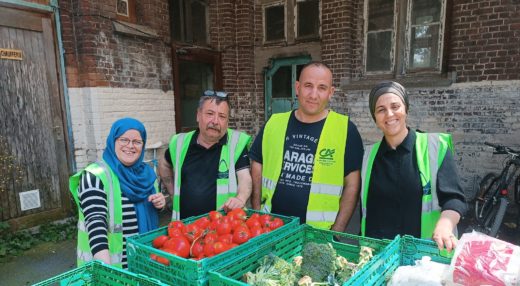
[365,0,446,75]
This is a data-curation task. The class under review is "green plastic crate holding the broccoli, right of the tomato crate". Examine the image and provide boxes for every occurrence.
[209,225,391,286]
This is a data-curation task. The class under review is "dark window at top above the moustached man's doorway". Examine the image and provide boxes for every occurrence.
[170,0,209,45]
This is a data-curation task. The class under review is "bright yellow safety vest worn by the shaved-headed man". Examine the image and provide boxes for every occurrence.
[262,111,348,229]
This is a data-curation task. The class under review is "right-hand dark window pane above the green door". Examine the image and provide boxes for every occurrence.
[296,0,320,39]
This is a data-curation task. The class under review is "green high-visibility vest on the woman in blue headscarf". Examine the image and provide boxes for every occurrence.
[69,161,123,268]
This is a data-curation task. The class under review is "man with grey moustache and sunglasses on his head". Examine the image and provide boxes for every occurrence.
[159,90,252,220]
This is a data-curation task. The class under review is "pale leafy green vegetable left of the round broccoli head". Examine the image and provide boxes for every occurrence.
[245,254,296,286]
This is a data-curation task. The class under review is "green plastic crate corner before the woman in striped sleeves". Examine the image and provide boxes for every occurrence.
[34,260,166,286]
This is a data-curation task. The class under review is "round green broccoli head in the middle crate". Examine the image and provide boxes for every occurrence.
[301,242,336,281]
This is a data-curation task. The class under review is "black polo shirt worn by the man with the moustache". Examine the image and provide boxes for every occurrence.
[164,130,250,219]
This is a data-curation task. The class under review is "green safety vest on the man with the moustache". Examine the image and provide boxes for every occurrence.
[169,128,251,220]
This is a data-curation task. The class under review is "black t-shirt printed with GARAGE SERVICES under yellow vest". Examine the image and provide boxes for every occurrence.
[249,112,363,223]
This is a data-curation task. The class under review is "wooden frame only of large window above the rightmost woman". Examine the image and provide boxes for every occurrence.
[363,0,448,78]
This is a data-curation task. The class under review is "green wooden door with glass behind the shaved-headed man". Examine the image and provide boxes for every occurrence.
[264,56,311,120]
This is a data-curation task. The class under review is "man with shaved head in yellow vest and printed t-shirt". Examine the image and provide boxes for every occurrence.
[250,62,363,232]
